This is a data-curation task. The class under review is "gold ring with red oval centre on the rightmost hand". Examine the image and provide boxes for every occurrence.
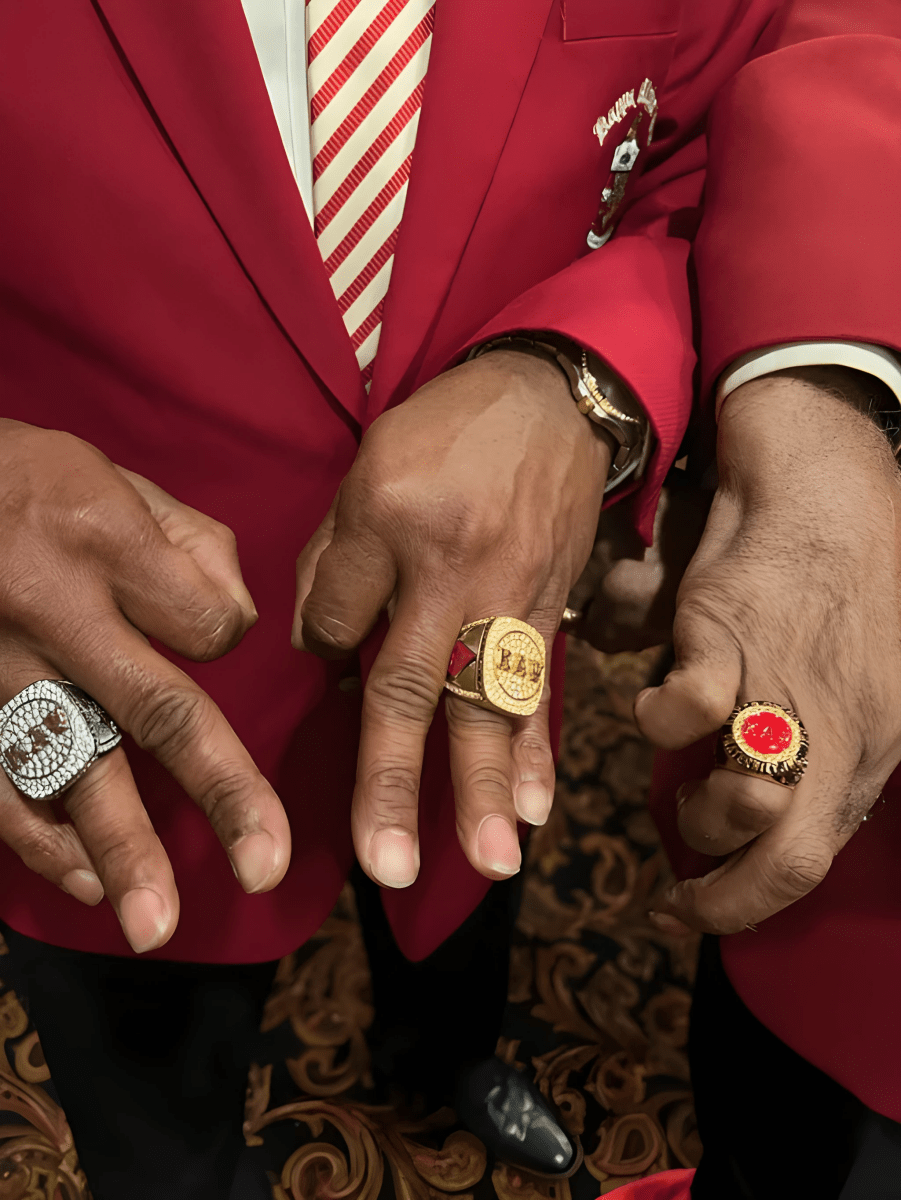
[716,701,810,787]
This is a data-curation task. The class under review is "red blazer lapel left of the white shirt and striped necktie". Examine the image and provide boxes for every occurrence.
[92,0,365,420]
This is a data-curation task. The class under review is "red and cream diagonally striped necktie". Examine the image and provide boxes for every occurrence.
[306,0,434,388]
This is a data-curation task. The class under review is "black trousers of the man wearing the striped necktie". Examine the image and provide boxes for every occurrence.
[0,871,518,1200]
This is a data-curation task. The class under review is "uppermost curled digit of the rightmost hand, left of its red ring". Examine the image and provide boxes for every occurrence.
[635,595,741,750]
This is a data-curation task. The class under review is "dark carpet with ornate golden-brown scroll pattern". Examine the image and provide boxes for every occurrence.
[0,643,701,1200]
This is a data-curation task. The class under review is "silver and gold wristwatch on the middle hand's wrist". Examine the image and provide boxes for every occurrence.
[467,332,653,492]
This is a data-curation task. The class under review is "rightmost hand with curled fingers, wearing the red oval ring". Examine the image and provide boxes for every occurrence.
[636,368,901,934]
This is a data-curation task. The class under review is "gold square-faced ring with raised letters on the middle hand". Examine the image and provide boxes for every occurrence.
[444,617,545,716]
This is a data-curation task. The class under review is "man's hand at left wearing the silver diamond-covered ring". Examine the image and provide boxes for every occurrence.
[0,421,290,952]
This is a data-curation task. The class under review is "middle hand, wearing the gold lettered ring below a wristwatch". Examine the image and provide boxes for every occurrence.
[295,350,612,887]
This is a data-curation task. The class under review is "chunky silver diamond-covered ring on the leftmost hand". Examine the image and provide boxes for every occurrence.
[0,679,122,800]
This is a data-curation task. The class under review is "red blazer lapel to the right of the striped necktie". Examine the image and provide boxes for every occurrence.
[366,0,558,424]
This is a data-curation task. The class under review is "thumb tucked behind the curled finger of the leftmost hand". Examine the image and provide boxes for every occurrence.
[116,467,258,628]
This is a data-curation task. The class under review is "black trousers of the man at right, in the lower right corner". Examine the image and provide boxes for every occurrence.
[689,937,901,1200]
